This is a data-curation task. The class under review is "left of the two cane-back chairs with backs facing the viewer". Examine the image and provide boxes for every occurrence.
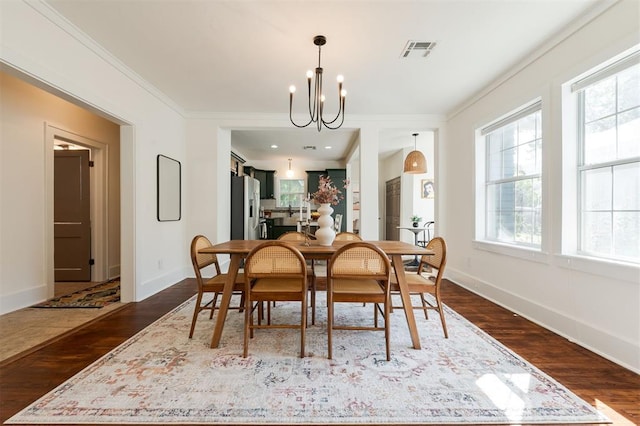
[243,240,307,358]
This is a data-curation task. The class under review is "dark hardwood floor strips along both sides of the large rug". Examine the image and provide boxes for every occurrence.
[0,279,640,425]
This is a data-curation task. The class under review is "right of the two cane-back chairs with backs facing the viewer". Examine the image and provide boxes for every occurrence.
[327,241,391,361]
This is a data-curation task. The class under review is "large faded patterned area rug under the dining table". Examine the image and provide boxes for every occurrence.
[7,297,607,425]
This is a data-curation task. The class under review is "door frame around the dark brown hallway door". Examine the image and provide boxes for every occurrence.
[44,122,109,297]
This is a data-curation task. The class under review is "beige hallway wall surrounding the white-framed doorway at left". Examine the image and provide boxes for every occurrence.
[0,72,120,293]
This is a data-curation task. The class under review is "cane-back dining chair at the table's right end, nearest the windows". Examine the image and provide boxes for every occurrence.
[391,237,449,338]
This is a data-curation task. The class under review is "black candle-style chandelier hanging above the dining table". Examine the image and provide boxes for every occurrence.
[289,36,347,131]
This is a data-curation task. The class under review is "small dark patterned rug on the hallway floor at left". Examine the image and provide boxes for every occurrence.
[32,280,120,308]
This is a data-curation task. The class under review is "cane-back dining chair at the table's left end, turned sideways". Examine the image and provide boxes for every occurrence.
[189,235,244,338]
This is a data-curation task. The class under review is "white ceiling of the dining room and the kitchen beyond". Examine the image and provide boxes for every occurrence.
[47,0,597,160]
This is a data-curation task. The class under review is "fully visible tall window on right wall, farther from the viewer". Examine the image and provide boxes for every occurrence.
[479,101,542,249]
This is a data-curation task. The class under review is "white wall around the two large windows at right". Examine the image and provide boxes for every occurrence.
[439,0,640,372]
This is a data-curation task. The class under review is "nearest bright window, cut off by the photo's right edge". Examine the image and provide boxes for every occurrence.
[571,52,640,263]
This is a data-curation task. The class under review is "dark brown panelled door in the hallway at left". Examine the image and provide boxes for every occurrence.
[53,150,91,281]
